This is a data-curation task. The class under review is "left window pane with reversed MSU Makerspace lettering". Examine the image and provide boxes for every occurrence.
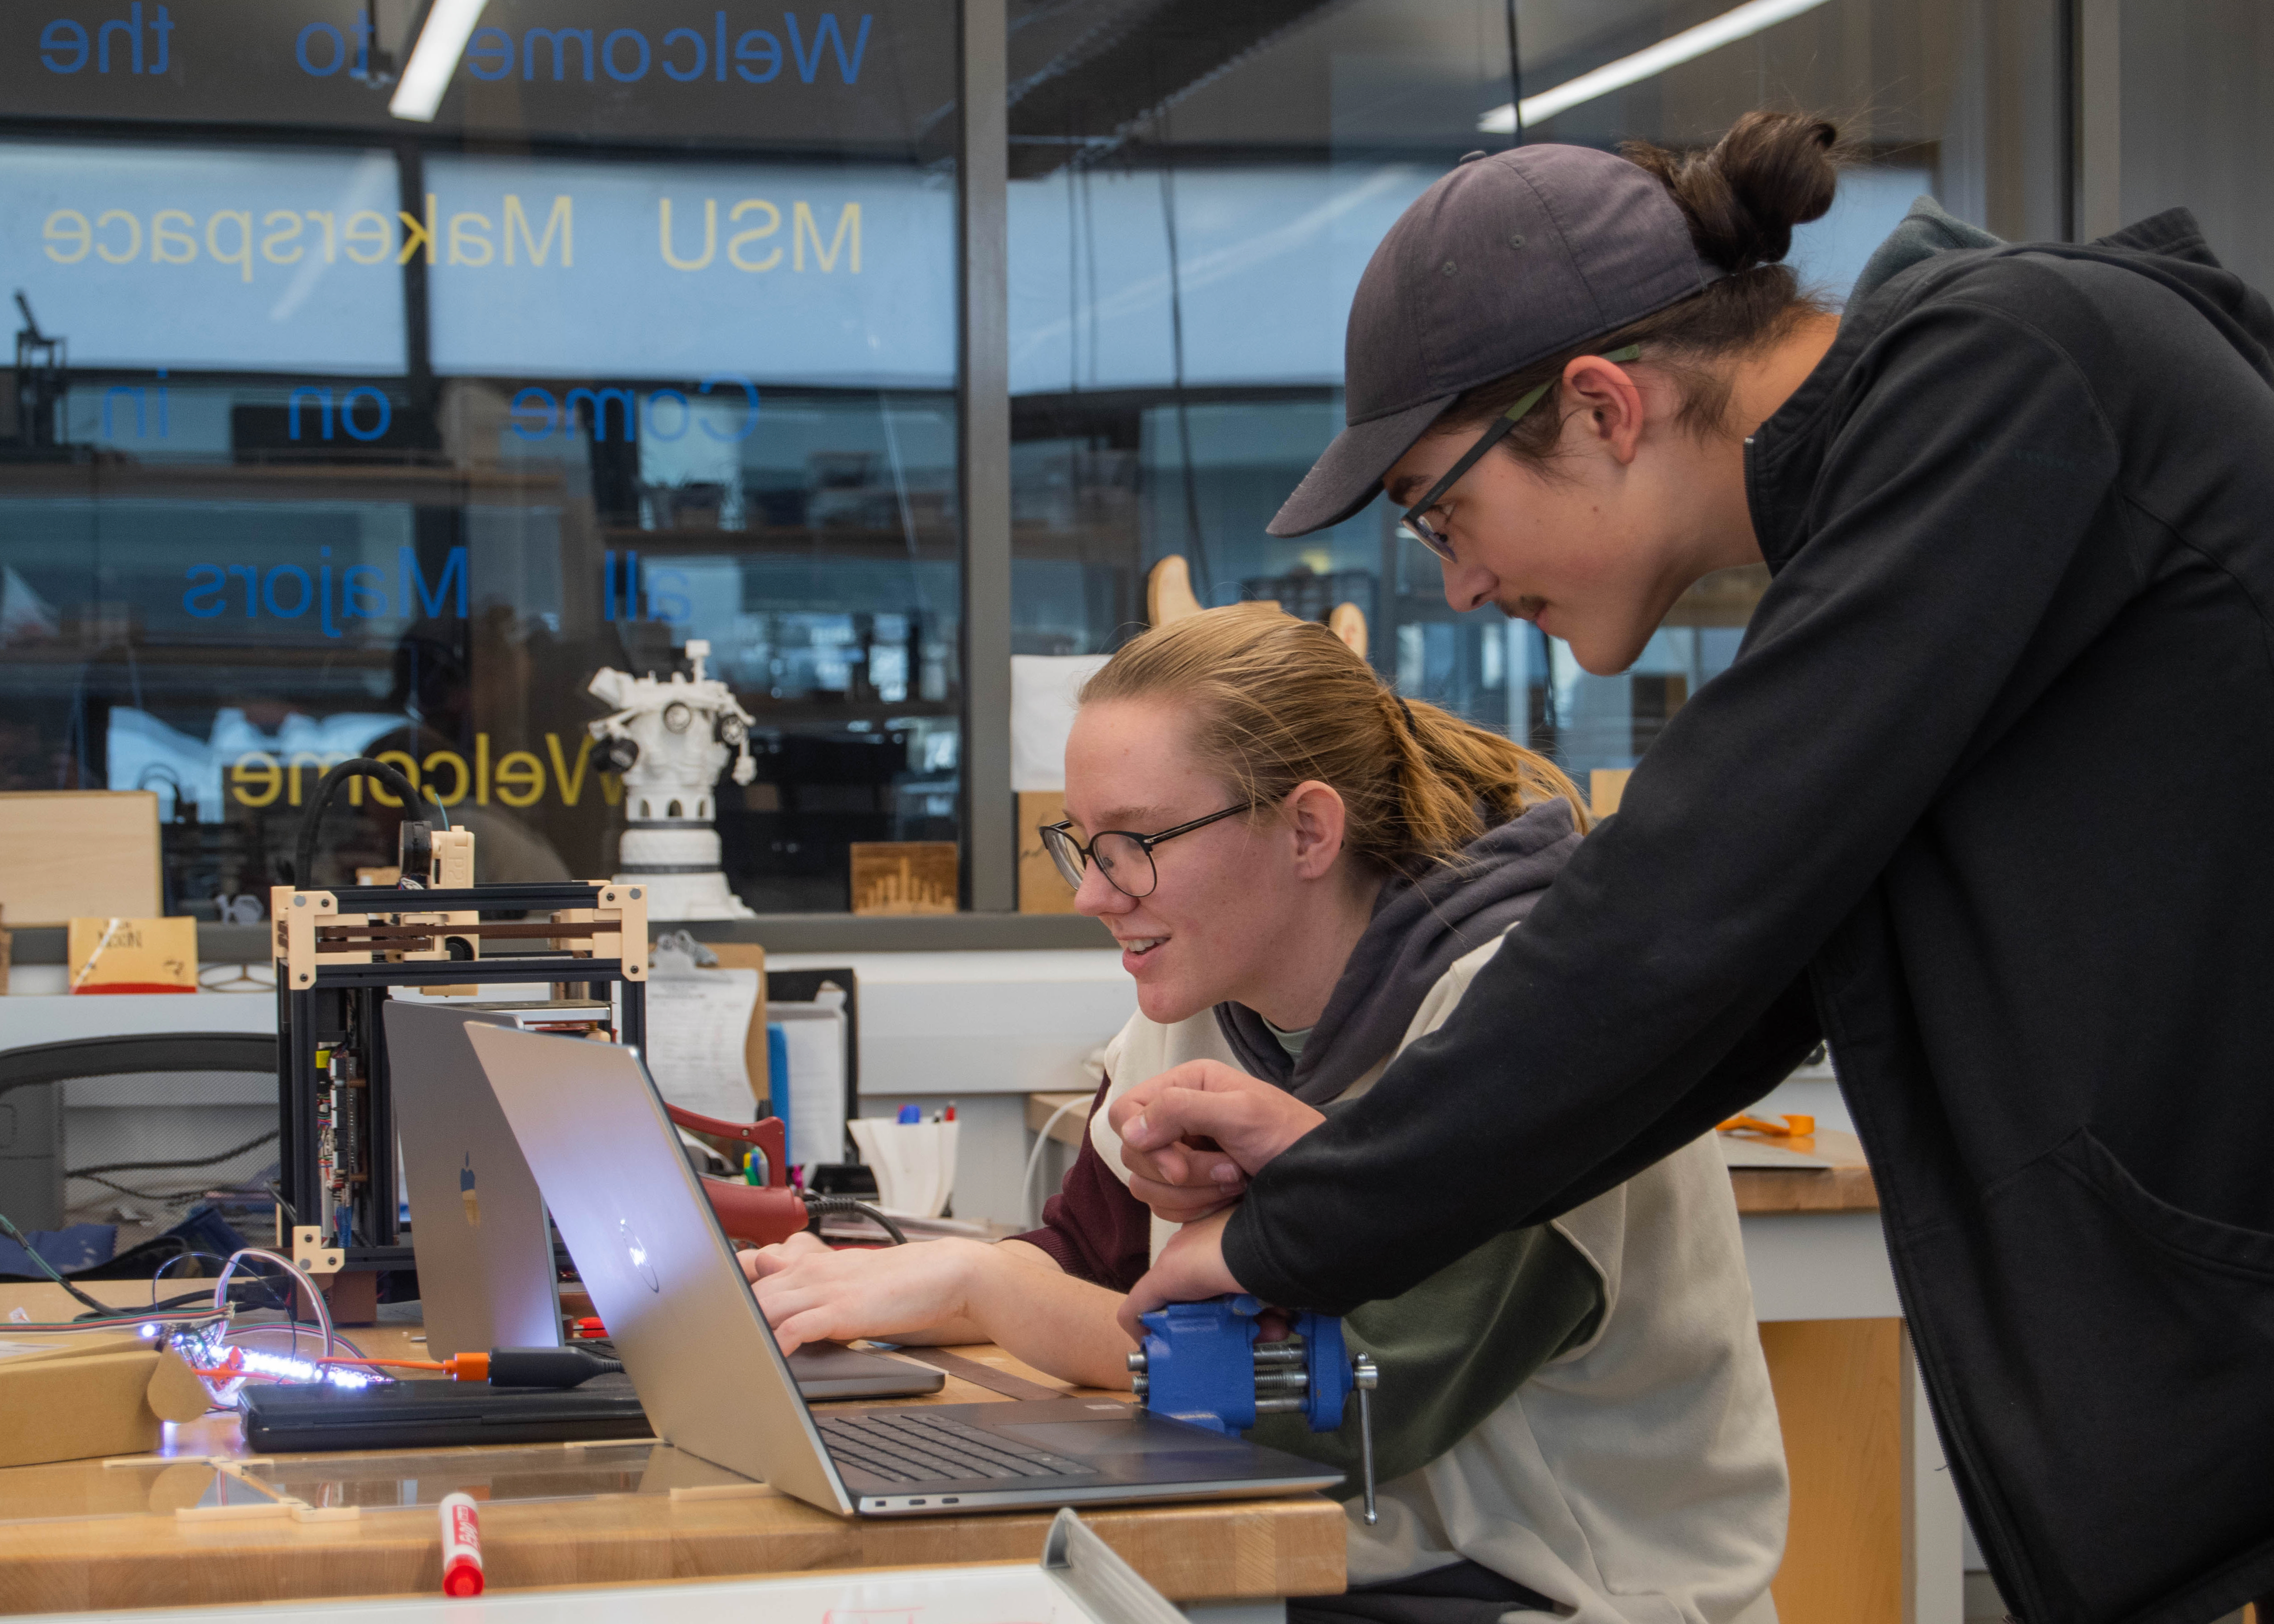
[0,0,964,921]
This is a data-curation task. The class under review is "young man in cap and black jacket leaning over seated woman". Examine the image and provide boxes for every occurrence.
[1112,114,2274,1624]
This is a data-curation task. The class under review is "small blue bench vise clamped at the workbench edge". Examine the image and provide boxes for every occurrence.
[1130,1292,1378,1524]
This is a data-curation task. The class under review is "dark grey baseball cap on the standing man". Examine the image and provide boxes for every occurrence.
[1269,143,1724,537]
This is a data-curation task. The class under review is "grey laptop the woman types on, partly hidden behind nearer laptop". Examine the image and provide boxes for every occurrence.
[395,1001,946,1399]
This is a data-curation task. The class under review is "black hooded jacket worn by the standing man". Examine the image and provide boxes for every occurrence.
[1223,212,2274,1624]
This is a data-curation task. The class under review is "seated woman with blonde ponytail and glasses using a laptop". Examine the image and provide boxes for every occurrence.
[744,605,1785,1624]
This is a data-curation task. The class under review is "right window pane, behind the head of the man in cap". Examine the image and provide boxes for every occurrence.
[1010,0,2065,773]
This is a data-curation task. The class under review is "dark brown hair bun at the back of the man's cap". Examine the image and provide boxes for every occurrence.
[1619,112,1844,273]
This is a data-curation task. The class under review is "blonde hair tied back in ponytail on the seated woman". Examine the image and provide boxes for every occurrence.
[1082,603,1587,878]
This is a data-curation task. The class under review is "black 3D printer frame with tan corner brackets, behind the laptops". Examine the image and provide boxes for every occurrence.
[271,880,648,1269]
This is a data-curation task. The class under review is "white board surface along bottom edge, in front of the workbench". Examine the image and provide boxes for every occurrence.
[23,1563,1098,1624]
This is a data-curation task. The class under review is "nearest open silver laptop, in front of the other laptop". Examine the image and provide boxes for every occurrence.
[466,1026,1342,1517]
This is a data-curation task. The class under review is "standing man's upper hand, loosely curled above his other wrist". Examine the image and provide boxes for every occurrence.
[1105,1060,1326,1224]
